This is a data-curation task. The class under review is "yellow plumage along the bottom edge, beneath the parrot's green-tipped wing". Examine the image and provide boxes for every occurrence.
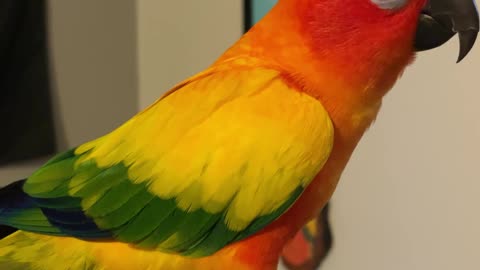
[0,230,255,270]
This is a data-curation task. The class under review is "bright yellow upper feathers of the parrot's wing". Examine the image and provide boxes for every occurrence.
[76,61,333,231]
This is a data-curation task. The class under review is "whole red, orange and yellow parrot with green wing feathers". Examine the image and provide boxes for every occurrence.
[0,0,479,270]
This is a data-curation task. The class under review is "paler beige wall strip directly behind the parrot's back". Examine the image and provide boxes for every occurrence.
[137,0,243,108]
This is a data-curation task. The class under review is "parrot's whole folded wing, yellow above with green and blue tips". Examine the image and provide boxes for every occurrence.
[4,60,333,256]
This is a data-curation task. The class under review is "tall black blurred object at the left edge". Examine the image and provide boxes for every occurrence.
[0,0,55,165]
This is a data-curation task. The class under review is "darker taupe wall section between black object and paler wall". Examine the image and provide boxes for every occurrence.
[49,0,138,146]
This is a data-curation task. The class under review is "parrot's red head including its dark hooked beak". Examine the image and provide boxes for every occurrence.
[290,0,479,62]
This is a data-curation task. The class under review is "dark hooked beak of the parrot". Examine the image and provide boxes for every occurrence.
[415,0,479,63]
